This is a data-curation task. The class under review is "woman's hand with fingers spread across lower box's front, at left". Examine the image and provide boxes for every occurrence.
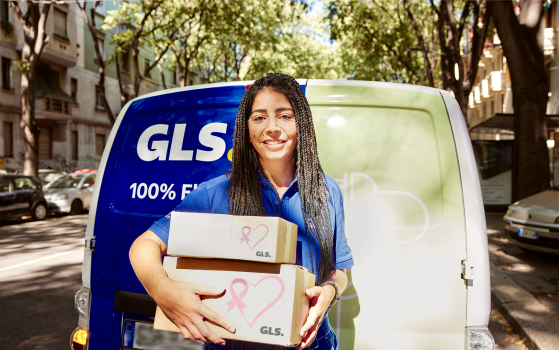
[154,278,235,345]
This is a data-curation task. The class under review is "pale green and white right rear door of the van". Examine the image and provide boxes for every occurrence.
[307,80,466,350]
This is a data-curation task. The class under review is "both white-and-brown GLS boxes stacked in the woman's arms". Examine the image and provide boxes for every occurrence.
[154,212,315,347]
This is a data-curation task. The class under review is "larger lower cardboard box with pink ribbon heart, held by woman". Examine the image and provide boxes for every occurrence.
[154,256,315,347]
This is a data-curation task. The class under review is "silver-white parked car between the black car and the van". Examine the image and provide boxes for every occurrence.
[45,173,97,215]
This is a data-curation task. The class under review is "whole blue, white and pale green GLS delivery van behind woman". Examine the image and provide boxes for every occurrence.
[71,79,494,350]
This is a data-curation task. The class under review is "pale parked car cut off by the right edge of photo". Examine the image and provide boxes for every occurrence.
[503,186,559,254]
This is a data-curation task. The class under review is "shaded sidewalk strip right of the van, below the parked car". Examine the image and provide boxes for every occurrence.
[486,213,559,350]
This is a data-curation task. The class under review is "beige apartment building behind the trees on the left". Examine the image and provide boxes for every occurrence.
[0,0,200,172]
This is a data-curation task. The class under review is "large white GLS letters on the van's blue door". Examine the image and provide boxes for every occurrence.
[138,123,227,162]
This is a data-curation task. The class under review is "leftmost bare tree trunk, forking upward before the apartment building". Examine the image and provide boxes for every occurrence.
[10,1,52,176]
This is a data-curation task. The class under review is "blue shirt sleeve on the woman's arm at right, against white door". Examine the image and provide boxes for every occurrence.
[328,180,354,270]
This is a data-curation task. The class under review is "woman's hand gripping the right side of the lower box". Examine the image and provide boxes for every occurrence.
[297,285,336,350]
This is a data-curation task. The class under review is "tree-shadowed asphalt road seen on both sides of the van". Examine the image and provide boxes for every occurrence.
[0,215,540,350]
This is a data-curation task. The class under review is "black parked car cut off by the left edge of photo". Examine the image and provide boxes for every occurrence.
[0,175,47,220]
